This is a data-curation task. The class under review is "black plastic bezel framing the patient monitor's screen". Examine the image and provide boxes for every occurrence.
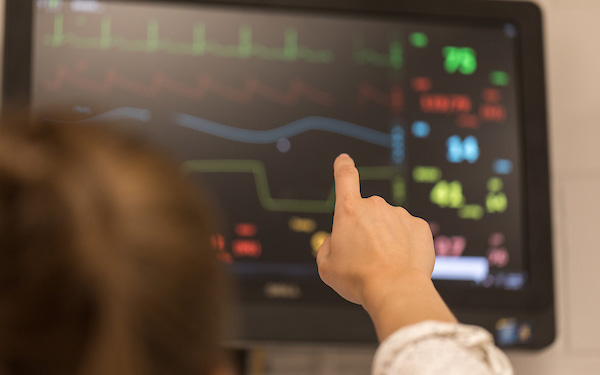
[2,0,554,347]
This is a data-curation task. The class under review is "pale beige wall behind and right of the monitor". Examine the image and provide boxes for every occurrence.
[0,0,600,375]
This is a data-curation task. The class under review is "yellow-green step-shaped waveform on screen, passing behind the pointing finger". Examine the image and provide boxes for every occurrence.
[182,160,405,214]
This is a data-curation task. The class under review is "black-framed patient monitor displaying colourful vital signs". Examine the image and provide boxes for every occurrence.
[4,0,554,345]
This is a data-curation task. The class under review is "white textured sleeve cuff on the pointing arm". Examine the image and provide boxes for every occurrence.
[372,321,513,375]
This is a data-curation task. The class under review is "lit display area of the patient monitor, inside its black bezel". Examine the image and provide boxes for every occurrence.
[33,1,527,300]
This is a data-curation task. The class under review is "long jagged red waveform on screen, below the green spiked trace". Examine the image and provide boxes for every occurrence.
[45,62,334,106]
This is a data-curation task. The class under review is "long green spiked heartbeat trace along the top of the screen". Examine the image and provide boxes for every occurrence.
[43,14,334,63]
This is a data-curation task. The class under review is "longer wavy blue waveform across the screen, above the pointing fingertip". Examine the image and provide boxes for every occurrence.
[175,113,392,148]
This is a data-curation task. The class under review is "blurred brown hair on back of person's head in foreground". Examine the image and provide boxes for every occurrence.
[0,121,223,375]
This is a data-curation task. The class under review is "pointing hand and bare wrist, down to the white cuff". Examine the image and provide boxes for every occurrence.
[317,154,455,338]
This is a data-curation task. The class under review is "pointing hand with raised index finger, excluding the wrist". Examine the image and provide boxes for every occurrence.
[317,154,435,305]
